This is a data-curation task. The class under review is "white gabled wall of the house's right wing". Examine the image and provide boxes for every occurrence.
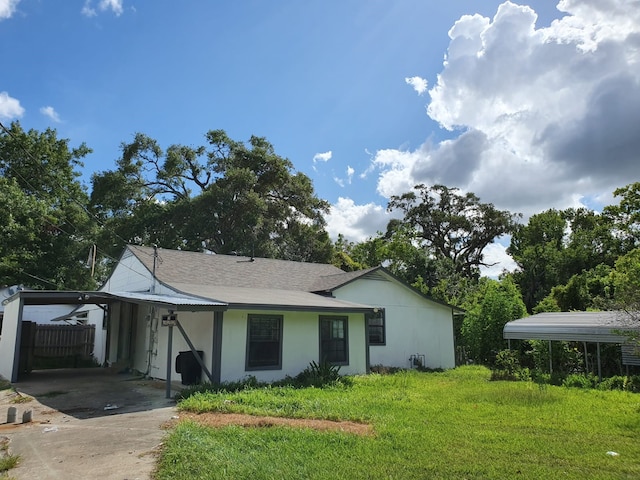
[333,278,455,368]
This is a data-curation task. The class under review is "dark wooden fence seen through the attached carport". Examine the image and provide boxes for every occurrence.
[33,325,96,358]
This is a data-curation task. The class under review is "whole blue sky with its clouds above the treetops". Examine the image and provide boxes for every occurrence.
[0,0,640,274]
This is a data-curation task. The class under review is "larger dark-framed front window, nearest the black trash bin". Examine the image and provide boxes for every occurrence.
[246,315,282,370]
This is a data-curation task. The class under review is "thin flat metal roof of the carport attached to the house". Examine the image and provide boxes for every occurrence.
[2,290,227,312]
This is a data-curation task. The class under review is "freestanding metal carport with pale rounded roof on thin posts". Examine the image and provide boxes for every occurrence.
[503,311,640,378]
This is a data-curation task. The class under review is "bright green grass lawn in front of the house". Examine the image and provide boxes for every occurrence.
[156,367,640,480]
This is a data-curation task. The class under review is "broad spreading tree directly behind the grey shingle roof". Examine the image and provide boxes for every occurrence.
[92,130,332,261]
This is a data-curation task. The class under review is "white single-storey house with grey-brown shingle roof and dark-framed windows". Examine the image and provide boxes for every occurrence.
[0,246,461,383]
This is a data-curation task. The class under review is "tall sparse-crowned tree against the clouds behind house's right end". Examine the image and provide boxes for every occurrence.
[388,185,518,277]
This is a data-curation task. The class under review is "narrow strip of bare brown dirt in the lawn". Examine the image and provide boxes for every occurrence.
[176,412,373,435]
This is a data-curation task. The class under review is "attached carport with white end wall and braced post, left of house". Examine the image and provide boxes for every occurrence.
[0,290,227,395]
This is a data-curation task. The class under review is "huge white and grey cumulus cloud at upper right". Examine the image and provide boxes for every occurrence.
[324,0,640,274]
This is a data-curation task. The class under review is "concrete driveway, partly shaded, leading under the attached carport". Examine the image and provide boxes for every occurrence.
[0,368,180,480]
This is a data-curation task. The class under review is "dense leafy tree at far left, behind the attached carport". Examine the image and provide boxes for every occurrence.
[0,122,96,289]
